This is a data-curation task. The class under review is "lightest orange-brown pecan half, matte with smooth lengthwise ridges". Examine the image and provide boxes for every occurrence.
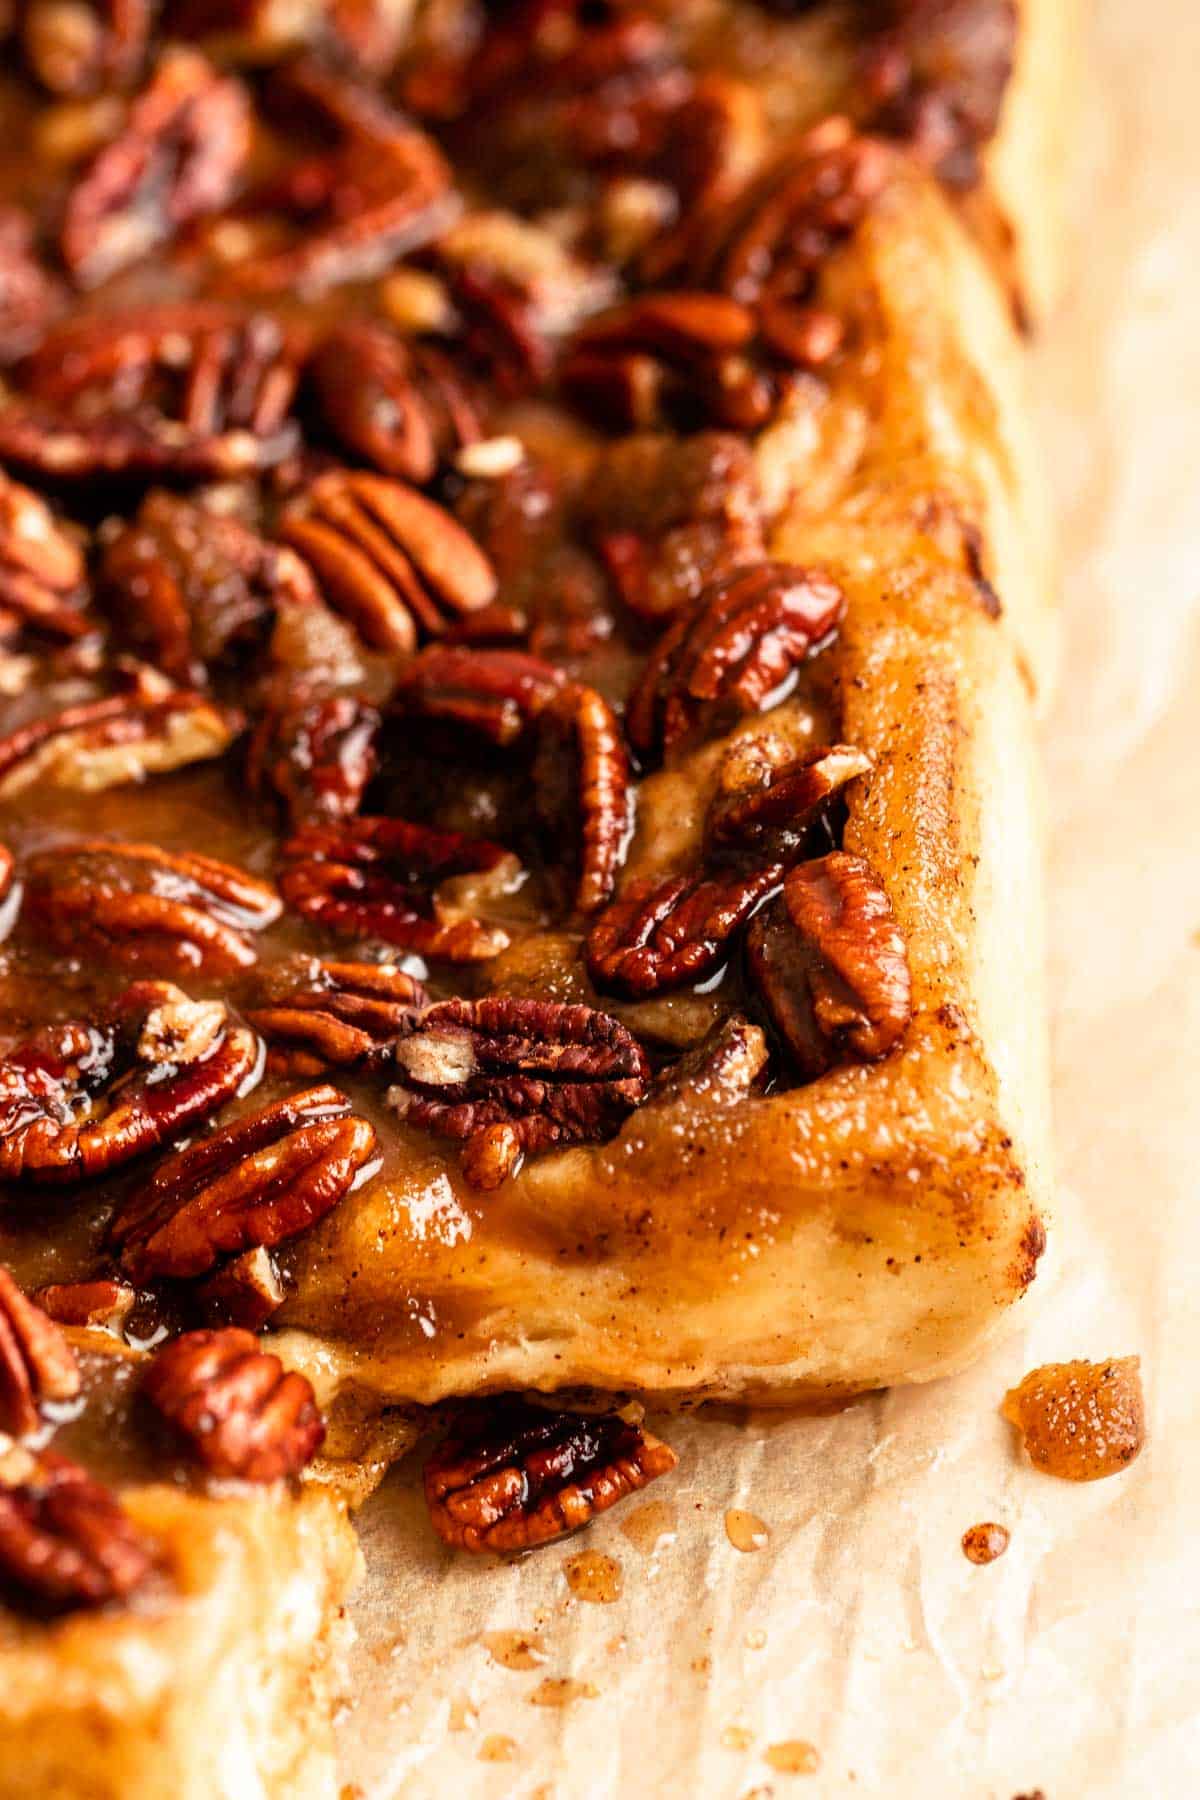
[281,470,497,652]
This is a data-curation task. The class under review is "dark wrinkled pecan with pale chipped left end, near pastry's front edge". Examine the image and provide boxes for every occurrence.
[387,995,648,1188]
